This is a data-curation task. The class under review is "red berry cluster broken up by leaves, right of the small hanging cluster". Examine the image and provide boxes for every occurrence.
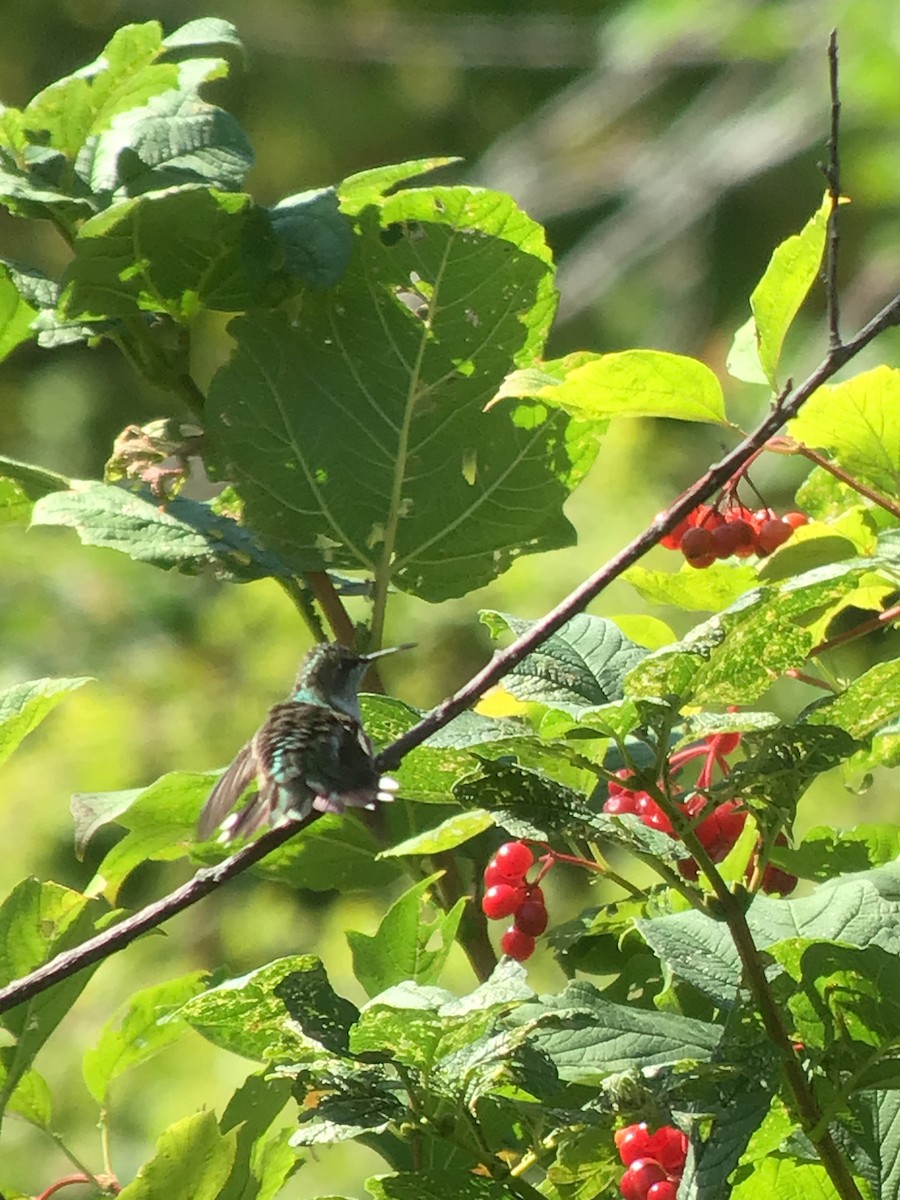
[604,733,797,895]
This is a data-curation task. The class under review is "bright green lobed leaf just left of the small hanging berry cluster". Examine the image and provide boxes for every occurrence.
[347,871,466,996]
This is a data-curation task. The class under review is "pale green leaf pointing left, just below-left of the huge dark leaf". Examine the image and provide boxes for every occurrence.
[32,481,289,583]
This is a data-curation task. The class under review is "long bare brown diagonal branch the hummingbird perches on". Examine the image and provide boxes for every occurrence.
[0,288,900,1013]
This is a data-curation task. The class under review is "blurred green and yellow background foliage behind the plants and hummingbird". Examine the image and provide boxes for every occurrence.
[0,0,900,1198]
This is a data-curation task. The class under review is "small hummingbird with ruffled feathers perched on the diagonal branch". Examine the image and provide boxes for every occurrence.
[197,642,410,842]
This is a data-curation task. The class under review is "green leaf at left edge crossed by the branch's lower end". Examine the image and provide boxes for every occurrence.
[0,880,100,1114]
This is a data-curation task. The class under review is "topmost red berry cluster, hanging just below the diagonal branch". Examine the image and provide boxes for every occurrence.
[660,504,808,568]
